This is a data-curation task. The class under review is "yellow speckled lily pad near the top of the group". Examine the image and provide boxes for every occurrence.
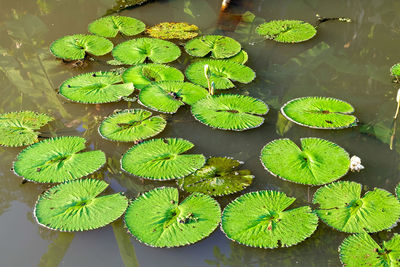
[146,22,199,40]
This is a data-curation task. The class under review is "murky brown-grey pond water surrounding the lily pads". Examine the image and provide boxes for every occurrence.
[0,0,400,267]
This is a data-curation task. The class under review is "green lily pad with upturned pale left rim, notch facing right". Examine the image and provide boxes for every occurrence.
[281,96,357,129]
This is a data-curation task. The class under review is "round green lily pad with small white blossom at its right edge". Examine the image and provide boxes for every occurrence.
[261,138,350,185]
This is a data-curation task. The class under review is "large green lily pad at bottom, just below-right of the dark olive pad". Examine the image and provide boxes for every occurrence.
[221,190,318,248]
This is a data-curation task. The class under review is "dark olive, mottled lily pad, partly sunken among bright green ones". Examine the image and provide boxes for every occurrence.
[177,157,254,196]
